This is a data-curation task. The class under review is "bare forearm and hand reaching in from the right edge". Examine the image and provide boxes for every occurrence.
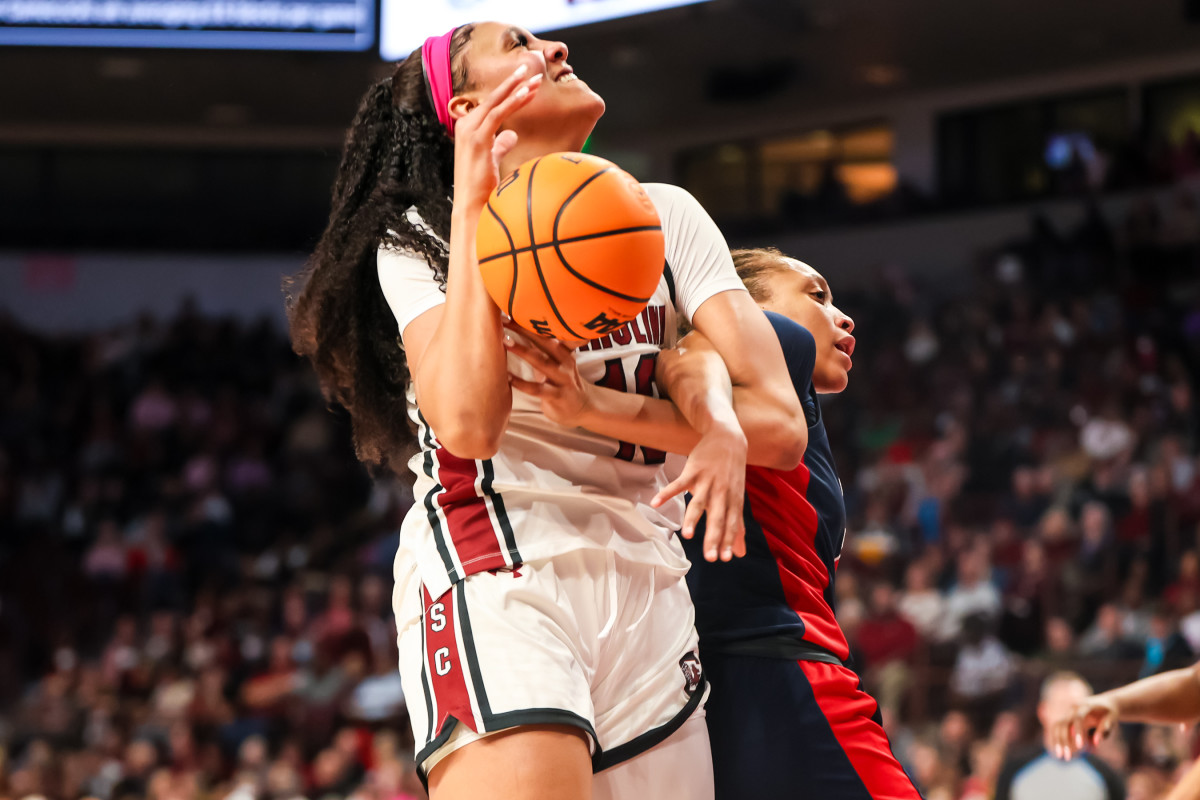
[1051,663,1200,758]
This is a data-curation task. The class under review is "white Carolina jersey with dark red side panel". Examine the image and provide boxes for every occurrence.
[378,184,744,597]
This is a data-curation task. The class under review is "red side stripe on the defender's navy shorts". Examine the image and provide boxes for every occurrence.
[799,661,920,800]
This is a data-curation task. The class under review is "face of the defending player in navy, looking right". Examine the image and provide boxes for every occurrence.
[758,258,854,395]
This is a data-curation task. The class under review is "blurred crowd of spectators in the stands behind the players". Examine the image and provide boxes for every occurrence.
[0,181,1200,800]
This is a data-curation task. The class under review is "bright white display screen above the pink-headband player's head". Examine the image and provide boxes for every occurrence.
[379,0,704,61]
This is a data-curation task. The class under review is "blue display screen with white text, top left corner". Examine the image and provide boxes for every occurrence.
[0,0,374,50]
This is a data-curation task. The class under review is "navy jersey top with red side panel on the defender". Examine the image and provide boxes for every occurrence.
[684,312,850,661]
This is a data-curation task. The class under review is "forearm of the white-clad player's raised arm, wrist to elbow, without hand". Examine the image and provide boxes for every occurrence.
[415,206,512,458]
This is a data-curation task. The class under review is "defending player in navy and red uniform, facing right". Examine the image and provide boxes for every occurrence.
[660,249,920,800]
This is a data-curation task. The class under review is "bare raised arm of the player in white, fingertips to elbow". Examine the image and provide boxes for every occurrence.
[401,68,541,458]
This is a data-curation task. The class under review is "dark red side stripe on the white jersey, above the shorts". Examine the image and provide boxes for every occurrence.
[433,447,510,578]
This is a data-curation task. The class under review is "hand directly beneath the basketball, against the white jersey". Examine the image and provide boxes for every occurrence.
[504,321,593,428]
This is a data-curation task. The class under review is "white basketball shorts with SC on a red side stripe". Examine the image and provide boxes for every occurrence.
[392,549,708,777]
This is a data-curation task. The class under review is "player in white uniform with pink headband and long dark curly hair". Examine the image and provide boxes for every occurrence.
[285,23,808,800]
